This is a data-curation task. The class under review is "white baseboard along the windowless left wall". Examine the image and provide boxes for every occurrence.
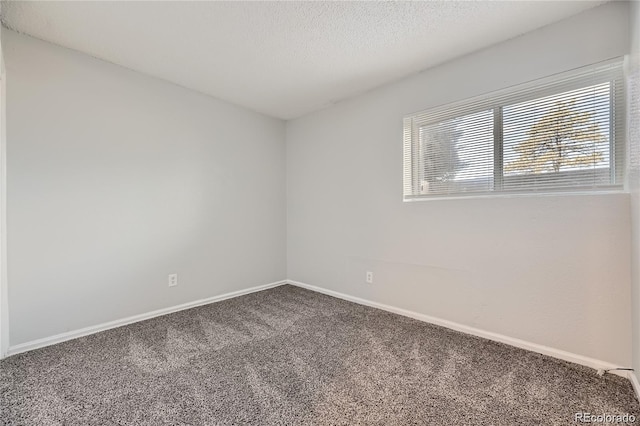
[7,281,287,356]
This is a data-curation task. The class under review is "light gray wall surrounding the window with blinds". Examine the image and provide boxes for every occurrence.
[287,2,631,365]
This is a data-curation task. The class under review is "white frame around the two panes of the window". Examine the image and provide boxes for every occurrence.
[403,58,626,201]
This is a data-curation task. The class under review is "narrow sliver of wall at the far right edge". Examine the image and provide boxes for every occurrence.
[628,2,640,382]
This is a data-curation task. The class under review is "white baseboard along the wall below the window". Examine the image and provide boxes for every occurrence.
[287,280,638,378]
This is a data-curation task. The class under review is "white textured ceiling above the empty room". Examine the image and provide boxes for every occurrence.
[2,1,604,119]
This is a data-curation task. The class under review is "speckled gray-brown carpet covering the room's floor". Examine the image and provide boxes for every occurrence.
[0,286,640,426]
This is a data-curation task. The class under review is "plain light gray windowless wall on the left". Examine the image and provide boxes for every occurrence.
[2,29,286,345]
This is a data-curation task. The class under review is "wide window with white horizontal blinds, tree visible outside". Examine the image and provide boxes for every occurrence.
[404,60,625,201]
